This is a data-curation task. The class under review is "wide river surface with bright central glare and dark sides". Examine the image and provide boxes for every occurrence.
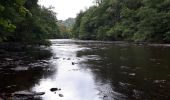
[0,39,170,100]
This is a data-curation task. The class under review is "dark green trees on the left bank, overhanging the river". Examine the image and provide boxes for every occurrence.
[0,0,61,45]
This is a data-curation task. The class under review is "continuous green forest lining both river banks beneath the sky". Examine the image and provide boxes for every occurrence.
[0,0,170,45]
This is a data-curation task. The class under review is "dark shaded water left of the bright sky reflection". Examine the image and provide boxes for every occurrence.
[0,43,52,100]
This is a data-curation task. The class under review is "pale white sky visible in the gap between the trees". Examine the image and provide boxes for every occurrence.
[38,0,93,20]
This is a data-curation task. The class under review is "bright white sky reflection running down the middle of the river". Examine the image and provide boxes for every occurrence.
[33,40,100,100]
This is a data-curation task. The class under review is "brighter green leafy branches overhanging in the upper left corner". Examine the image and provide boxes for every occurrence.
[0,0,29,42]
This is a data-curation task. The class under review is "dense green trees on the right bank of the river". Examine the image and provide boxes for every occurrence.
[72,0,170,42]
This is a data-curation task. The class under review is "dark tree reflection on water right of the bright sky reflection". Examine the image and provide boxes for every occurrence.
[77,42,170,100]
